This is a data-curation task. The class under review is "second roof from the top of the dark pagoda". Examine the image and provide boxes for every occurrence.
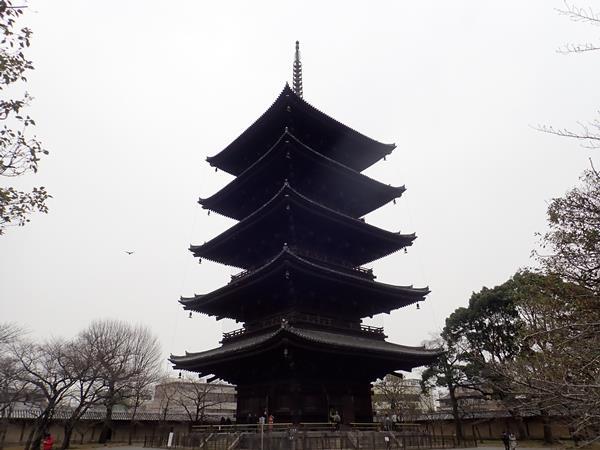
[198,129,406,220]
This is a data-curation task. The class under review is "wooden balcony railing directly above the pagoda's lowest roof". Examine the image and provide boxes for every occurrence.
[221,312,386,342]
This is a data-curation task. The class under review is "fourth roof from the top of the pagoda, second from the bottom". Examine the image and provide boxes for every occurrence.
[180,247,429,322]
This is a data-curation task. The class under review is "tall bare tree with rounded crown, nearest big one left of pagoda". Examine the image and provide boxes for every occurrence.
[81,320,161,443]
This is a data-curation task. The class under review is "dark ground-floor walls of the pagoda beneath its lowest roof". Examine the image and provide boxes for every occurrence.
[236,380,373,424]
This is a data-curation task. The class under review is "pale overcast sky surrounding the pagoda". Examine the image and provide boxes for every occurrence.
[0,0,600,367]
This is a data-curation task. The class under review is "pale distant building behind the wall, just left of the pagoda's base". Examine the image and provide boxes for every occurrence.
[147,379,237,423]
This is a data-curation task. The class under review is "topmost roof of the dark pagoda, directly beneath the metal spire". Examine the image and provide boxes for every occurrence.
[207,83,395,175]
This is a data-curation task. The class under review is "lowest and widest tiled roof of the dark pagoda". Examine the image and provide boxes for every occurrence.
[169,323,441,369]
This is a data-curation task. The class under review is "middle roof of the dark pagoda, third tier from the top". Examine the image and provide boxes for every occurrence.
[190,182,416,269]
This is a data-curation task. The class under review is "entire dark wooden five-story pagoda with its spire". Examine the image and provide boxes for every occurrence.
[171,43,438,423]
